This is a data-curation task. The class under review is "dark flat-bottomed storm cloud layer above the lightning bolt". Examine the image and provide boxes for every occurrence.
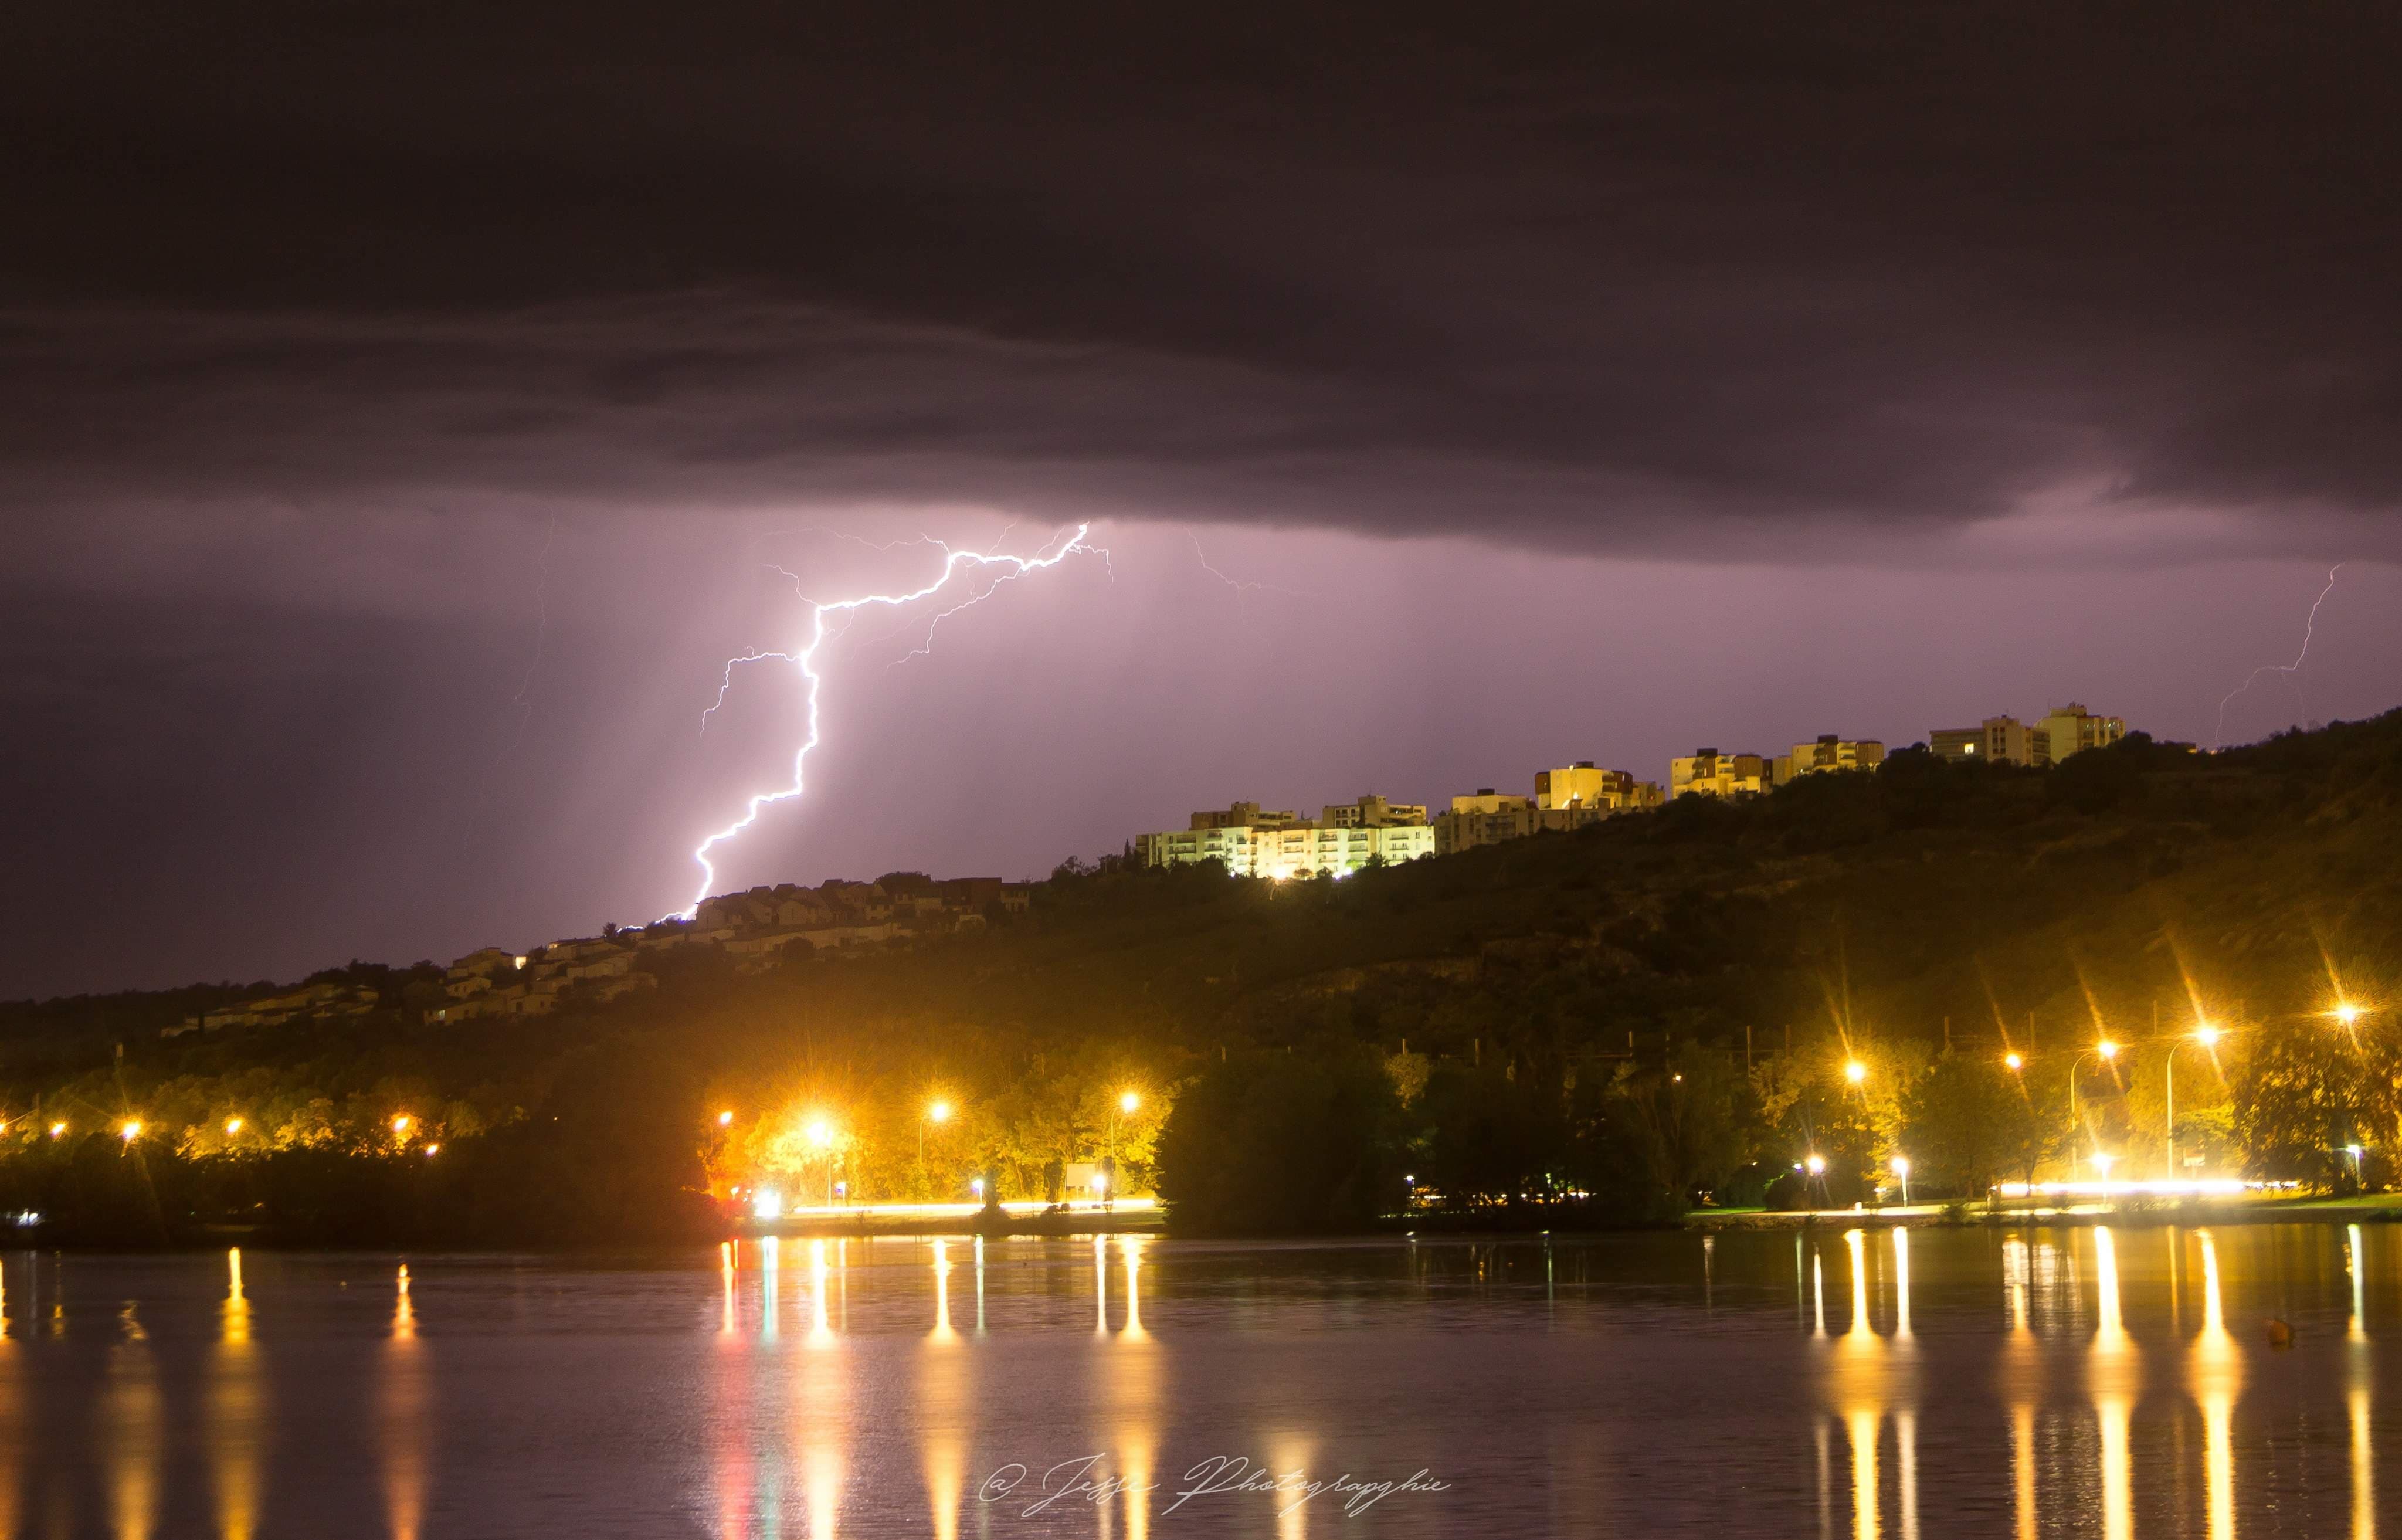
[0,5,2402,557]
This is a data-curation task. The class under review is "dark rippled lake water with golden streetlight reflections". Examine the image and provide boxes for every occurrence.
[0,1225,2402,1540]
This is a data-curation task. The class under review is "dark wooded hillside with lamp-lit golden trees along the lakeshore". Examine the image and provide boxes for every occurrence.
[0,714,2402,1244]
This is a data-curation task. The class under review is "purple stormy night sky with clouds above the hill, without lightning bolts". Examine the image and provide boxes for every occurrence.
[0,0,2402,995]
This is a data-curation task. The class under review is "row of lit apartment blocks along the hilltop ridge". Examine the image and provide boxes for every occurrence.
[1134,701,2126,877]
